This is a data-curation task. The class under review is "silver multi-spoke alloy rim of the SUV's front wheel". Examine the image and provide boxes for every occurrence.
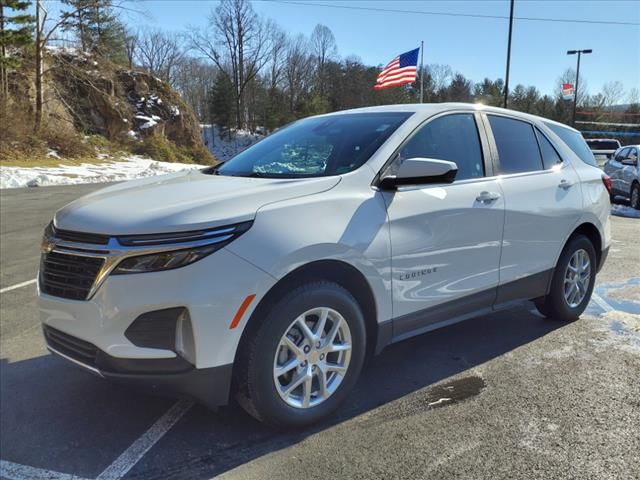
[273,307,351,408]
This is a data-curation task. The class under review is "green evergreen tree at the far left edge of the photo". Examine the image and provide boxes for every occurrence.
[0,0,35,104]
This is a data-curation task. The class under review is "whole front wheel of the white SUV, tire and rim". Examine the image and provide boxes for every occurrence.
[237,282,366,427]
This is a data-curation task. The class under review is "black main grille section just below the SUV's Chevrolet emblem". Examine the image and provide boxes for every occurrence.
[40,252,104,300]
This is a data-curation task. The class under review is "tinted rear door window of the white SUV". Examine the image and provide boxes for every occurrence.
[489,115,542,174]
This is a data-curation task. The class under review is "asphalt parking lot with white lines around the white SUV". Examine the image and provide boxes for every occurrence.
[0,185,640,480]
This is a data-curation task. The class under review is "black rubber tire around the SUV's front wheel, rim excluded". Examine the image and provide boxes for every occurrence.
[235,281,366,428]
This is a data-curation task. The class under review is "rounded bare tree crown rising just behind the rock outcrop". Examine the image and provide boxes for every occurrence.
[136,30,185,83]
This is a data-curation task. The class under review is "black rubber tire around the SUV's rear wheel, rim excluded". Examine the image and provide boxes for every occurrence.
[534,235,597,322]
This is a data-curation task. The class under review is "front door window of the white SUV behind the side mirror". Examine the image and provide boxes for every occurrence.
[400,113,484,180]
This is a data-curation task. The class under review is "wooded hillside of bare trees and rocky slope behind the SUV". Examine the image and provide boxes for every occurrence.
[0,0,640,165]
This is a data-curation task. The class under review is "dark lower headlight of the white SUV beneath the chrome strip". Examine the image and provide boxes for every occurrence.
[113,244,223,275]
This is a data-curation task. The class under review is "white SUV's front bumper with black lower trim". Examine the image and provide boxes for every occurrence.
[38,249,275,406]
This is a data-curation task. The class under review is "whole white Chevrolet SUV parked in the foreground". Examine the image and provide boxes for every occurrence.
[39,104,610,426]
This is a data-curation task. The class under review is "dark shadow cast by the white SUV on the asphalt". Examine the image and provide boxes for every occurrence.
[0,307,562,479]
